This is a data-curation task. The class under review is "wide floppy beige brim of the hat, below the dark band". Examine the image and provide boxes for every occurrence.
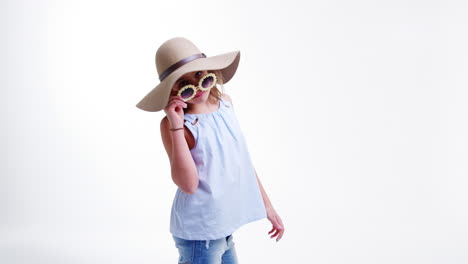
[136,50,240,112]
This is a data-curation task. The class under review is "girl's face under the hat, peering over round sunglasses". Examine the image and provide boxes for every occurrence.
[171,71,216,103]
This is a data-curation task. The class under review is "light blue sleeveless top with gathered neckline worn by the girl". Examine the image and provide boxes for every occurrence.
[170,99,266,240]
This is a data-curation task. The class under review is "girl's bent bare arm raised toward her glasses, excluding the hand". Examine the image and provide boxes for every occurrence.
[161,116,198,194]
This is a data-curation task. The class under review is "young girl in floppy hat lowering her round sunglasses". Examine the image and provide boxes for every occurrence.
[133,37,285,263]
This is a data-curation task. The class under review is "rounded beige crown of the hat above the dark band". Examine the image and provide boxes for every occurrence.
[155,37,201,75]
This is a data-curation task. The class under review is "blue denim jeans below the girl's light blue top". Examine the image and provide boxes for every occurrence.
[172,234,238,264]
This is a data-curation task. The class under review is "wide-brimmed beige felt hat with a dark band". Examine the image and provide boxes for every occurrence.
[136,37,240,112]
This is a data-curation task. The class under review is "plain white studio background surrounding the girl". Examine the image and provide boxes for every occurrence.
[0,0,468,264]
